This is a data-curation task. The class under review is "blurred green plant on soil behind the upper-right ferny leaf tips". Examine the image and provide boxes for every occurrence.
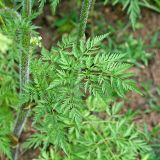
[95,33,151,67]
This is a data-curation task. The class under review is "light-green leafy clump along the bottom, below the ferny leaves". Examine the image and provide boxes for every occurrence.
[30,104,150,160]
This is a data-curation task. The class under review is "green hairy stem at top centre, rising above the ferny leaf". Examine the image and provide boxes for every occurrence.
[77,0,92,45]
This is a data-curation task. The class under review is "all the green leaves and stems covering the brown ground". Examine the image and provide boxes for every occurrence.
[0,0,160,160]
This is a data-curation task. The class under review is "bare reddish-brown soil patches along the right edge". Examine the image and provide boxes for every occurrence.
[128,10,160,130]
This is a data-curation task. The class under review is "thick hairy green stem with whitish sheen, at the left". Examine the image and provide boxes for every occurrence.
[13,0,31,160]
